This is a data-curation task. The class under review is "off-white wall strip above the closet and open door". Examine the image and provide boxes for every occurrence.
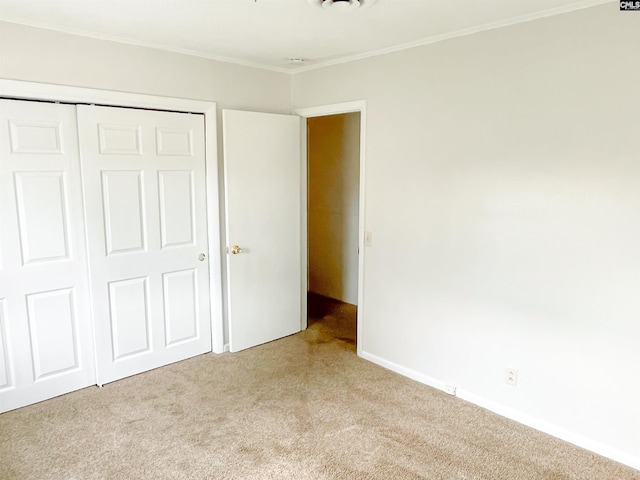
[0,22,291,113]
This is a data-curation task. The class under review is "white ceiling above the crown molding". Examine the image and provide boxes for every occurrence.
[0,0,611,72]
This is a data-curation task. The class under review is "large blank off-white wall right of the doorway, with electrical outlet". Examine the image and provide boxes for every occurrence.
[292,3,640,468]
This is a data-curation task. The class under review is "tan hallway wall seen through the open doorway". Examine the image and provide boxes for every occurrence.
[307,113,360,305]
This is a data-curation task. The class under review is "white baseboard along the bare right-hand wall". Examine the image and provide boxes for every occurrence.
[360,351,640,470]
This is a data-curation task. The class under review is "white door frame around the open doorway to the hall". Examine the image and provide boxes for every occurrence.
[293,100,367,356]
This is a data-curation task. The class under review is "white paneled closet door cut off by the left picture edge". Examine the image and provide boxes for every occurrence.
[0,100,95,411]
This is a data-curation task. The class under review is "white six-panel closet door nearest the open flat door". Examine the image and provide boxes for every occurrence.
[78,105,211,384]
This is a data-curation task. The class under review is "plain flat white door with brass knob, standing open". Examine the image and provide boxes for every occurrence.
[223,110,302,352]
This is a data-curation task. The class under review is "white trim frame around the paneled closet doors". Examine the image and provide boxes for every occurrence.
[0,78,224,353]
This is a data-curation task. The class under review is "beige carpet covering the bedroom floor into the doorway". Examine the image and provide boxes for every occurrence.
[0,296,640,480]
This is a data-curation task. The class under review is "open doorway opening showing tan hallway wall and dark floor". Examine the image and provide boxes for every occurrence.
[306,111,361,349]
